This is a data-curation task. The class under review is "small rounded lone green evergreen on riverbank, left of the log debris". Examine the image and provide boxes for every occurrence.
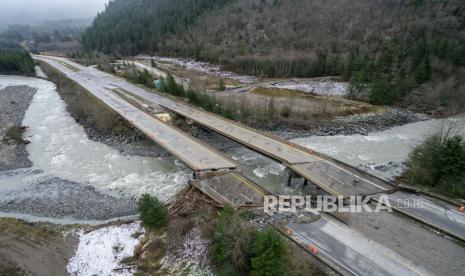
[138,194,168,229]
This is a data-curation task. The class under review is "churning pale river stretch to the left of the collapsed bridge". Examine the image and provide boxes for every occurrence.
[0,76,189,211]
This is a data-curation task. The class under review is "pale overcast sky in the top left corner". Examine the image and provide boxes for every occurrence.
[0,0,109,25]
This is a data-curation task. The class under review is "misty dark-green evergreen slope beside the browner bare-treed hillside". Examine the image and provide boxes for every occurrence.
[82,0,229,55]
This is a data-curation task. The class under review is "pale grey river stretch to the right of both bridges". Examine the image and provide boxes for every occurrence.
[293,116,465,179]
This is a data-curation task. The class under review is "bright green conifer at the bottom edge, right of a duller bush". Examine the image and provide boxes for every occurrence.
[250,228,287,276]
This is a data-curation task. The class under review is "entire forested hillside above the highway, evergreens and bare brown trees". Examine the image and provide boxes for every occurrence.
[82,0,465,112]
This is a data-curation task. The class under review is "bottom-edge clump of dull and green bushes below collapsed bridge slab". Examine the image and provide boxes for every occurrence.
[212,207,298,276]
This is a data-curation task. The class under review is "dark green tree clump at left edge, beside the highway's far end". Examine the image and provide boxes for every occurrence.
[0,41,35,76]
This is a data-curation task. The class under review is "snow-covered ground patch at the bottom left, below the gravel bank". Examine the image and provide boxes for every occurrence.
[67,223,144,276]
